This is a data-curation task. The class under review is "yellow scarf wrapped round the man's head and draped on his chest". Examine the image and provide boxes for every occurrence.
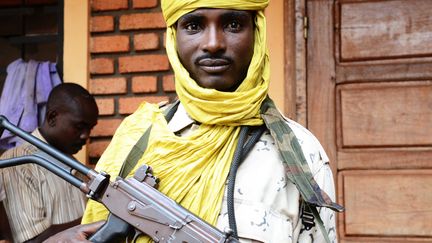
[150,0,270,224]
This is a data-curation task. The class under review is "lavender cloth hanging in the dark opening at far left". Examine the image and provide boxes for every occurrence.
[0,58,61,151]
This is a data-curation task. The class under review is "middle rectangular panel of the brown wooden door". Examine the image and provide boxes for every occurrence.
[337,82,432,148]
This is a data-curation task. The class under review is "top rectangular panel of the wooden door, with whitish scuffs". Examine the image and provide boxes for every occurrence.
[340,0,432,61]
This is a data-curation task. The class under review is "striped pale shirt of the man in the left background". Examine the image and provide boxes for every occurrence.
[0,130,85,242]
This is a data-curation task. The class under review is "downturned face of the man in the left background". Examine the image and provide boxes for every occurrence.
[50,100,98,155]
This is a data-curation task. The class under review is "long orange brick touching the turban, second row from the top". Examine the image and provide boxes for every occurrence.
[120,12,166,30]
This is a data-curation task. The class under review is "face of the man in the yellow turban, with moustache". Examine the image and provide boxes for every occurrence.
[176,9,254,91]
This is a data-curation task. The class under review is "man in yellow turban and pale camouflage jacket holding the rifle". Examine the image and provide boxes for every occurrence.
[44,0,342,243]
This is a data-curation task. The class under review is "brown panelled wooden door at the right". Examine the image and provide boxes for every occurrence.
[306,0,432,242]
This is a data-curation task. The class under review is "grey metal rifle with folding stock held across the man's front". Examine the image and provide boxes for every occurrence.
[0,116,239,243]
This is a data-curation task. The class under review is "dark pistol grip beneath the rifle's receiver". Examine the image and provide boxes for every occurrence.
[89,213,134,243]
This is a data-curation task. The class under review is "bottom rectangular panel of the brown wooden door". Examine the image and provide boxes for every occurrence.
[341,170,432,237]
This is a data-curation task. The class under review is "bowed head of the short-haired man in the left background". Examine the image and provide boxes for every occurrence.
[40,83,99,155]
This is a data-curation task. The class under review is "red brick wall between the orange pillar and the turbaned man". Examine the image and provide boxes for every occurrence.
[88,0,175,164]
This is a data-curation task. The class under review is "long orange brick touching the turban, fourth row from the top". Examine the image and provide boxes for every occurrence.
[119,55,170,73]
